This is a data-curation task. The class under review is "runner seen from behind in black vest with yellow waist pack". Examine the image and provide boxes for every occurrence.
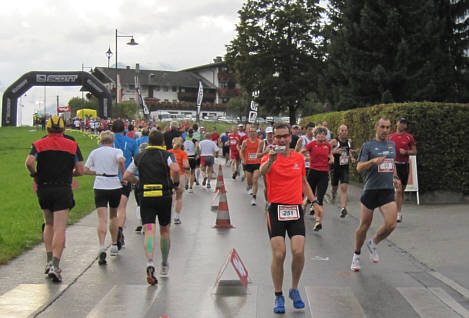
[124,131,179,285]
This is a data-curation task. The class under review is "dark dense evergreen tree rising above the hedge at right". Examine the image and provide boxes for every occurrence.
[320,0,468,109]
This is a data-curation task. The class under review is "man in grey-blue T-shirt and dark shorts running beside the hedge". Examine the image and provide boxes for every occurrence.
[350,118,401,272]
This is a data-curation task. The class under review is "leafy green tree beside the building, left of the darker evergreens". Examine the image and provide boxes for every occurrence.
[225,0,322,123]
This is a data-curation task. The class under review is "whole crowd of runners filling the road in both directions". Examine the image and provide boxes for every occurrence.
[26,116,417,313]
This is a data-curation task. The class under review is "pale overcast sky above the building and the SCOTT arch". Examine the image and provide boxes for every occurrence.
[0,0,244,124]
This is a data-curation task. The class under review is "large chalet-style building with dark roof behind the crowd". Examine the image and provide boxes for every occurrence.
[93,57,241,118]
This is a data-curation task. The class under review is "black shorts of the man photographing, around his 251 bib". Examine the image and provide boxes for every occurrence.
[267,203,305,238]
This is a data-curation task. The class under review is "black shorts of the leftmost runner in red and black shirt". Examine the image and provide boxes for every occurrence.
[37,185,75,212]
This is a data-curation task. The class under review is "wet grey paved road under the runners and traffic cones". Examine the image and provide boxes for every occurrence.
[0,163,469,318]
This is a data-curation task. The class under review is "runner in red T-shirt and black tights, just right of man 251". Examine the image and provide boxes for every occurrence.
[301,126,334,231]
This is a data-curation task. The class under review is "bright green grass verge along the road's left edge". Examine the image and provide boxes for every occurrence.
[0,127,97,264]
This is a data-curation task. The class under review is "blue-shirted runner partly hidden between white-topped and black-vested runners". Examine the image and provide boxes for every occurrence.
[112,120,138,250]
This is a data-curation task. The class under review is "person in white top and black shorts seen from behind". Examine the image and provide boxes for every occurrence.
[85,130,125,265]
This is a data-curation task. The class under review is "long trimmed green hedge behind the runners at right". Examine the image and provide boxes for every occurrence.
[301,102,469,195]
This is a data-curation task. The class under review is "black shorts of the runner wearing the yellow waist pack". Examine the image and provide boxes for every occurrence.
[140,196,173,226]
